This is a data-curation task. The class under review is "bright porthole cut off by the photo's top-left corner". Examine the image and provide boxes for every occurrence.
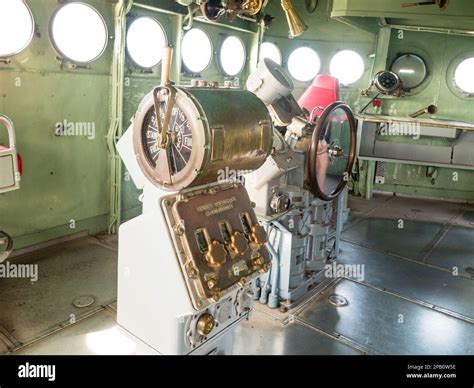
[0,0,35,57]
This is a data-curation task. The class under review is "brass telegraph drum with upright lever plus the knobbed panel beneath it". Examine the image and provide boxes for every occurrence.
[133,47,273,310]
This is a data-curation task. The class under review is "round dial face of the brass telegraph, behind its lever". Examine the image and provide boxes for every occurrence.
[141,102,193,174]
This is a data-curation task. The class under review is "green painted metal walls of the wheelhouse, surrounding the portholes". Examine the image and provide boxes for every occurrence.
[0,0,474,249]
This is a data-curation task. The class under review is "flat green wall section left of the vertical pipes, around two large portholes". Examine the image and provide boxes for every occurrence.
[0,0,114,248]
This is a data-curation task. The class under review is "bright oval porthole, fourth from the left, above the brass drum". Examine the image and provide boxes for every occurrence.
[181,28,212,73]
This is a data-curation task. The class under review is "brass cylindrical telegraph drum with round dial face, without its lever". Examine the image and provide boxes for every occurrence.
[133,87,273,191]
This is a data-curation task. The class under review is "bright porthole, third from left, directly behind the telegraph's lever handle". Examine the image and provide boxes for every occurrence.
[127,17,166,68]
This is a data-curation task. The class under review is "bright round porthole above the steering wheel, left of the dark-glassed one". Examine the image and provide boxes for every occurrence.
[329,50,365,85]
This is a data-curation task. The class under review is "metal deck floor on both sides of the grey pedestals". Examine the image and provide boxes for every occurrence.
[0,195,474,355]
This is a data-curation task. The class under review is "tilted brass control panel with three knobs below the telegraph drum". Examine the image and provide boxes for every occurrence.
[161,183,271,310]
